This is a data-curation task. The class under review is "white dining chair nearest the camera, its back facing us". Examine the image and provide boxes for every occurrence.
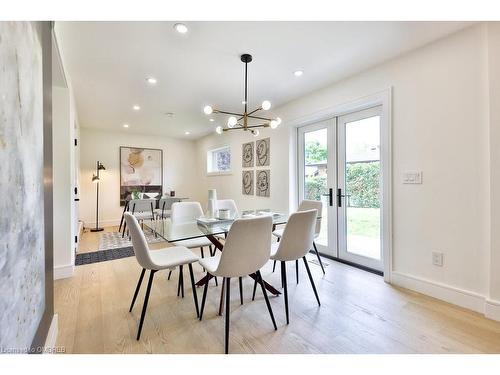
[200,216,277,354]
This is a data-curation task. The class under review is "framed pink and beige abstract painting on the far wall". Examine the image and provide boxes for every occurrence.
[120,146,163,205]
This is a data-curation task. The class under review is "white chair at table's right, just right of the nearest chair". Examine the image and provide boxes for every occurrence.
[254,209,321,324]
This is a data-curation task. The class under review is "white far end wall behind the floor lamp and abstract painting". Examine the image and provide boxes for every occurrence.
[80,128,199,227]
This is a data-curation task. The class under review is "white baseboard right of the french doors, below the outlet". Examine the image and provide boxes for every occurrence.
[391,271,488,320]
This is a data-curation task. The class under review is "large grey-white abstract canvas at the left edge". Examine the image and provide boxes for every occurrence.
[0,22,45,351]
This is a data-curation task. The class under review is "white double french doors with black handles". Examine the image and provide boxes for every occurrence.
[298,106,383,271]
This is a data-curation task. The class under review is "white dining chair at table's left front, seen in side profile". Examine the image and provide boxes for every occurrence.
[124,212,199,340]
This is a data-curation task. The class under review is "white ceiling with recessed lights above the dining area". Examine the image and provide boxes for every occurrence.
[56,22,469,139]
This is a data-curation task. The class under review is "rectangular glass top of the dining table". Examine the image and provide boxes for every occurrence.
[144,209,289,244]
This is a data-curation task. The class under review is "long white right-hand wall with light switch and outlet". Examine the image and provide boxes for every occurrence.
[198,24,500,320]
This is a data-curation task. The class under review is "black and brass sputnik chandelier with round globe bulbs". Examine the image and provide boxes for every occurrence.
[203,54,281,136]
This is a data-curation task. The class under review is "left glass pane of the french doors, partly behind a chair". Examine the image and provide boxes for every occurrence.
[304,128,328,246]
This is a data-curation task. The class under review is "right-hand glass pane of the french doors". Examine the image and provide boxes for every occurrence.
[344,116,381,260]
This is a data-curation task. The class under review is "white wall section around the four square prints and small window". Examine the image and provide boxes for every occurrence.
[197,127,289,211]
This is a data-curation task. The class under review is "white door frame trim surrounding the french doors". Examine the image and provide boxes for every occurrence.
[287,87,393,283]
